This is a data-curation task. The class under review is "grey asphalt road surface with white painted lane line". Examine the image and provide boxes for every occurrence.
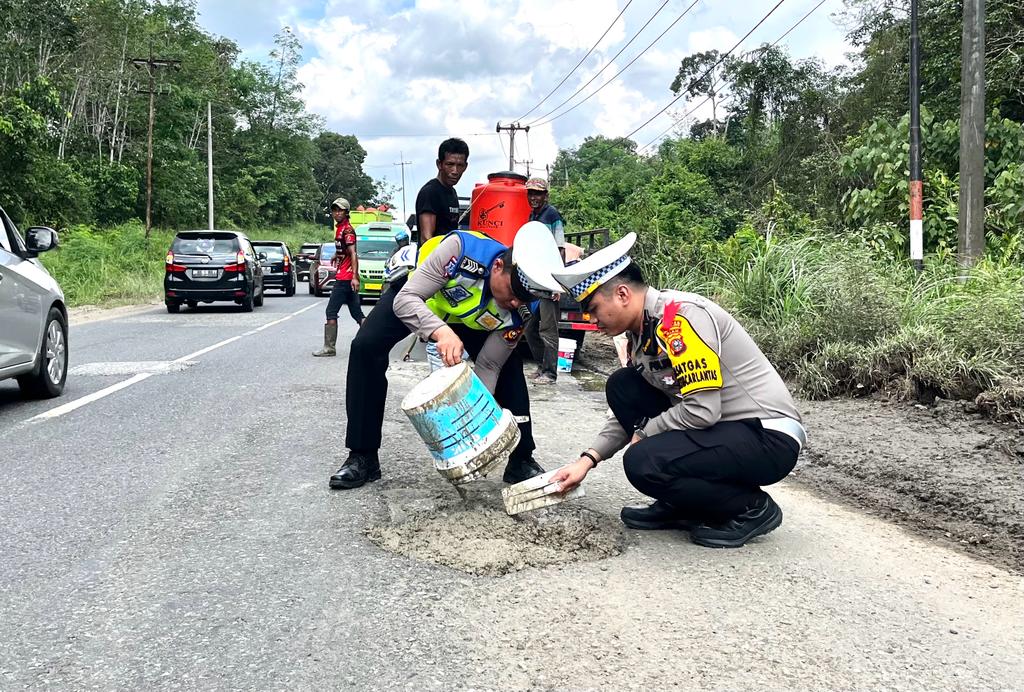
[0,294,1024,690]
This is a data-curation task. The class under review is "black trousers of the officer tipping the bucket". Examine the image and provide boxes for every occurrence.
[345,280,537,461]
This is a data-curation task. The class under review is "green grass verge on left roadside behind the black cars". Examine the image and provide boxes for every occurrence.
[41,221,333,307]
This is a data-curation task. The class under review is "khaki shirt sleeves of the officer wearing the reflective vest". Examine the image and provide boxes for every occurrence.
[393,233,523,394]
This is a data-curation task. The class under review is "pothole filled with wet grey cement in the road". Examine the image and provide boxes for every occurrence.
[367,479,626,576]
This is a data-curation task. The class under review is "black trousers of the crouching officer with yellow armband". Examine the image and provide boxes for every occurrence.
[605,367,800,522]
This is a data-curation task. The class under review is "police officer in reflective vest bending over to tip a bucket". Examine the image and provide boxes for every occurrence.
[331,223,563,488]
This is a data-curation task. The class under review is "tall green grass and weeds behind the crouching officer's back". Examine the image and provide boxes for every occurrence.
[643,232,1024,422]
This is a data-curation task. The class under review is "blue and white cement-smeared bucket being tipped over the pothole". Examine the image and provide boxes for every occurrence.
[401,362,519,485]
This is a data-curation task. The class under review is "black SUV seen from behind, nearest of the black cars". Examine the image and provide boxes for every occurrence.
[164,230,265,312]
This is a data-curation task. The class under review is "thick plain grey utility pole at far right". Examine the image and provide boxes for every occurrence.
[956,0,985,266]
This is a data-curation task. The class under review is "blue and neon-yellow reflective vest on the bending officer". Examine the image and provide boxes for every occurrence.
[417,230,529,332]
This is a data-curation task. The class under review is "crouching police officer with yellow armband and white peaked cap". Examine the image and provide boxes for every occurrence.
[552,233,806,548]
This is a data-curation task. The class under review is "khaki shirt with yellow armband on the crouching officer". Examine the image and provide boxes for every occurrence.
[591,288,800,459]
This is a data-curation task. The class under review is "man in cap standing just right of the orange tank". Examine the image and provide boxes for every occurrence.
[526,178,565,385]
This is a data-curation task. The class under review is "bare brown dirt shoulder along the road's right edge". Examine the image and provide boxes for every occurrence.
[580,334,1024,573]
